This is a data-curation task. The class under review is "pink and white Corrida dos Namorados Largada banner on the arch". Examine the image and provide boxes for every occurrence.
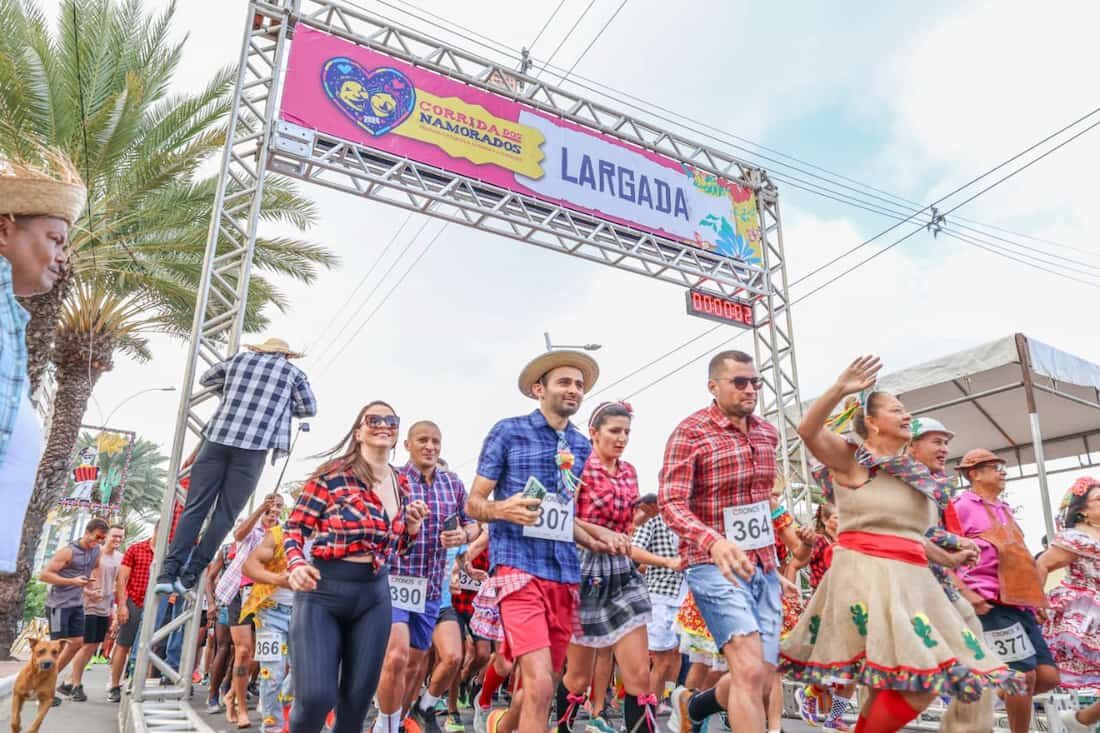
[279,26,763,266]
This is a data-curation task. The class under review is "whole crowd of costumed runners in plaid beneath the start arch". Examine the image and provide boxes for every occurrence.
[32,339,1100,733]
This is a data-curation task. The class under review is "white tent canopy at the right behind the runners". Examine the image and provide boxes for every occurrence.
[878,333,1100,536]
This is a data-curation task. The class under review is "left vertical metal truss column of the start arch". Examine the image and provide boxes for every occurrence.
[122,0,299,717]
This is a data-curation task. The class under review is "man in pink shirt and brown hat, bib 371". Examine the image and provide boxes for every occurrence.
[945,448,1060,733]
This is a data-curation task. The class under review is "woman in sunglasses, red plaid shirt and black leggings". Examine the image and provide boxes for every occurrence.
[284,401,428,733]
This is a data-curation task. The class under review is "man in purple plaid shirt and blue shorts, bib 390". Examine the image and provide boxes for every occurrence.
[374,415,480,733]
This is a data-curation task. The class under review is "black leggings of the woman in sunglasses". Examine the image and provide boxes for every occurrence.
[290,560,391,733]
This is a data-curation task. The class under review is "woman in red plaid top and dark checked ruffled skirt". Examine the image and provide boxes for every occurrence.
[557,402,681,733]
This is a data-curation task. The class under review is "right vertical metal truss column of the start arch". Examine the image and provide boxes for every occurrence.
[752,186,813,516]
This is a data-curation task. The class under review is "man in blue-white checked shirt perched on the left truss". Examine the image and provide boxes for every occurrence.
[156,338,317,593]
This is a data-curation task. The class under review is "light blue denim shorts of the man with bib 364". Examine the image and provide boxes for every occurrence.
[684,564,783,665]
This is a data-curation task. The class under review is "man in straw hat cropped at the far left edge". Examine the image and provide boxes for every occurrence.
[0,149,86,572]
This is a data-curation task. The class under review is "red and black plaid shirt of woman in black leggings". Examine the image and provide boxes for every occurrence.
[283,469,413,569]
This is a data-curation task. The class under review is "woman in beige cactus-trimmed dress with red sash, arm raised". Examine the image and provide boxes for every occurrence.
[780,357,1023,733]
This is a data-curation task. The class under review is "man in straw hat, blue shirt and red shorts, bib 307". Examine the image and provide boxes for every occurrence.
[466,351,628,733]
